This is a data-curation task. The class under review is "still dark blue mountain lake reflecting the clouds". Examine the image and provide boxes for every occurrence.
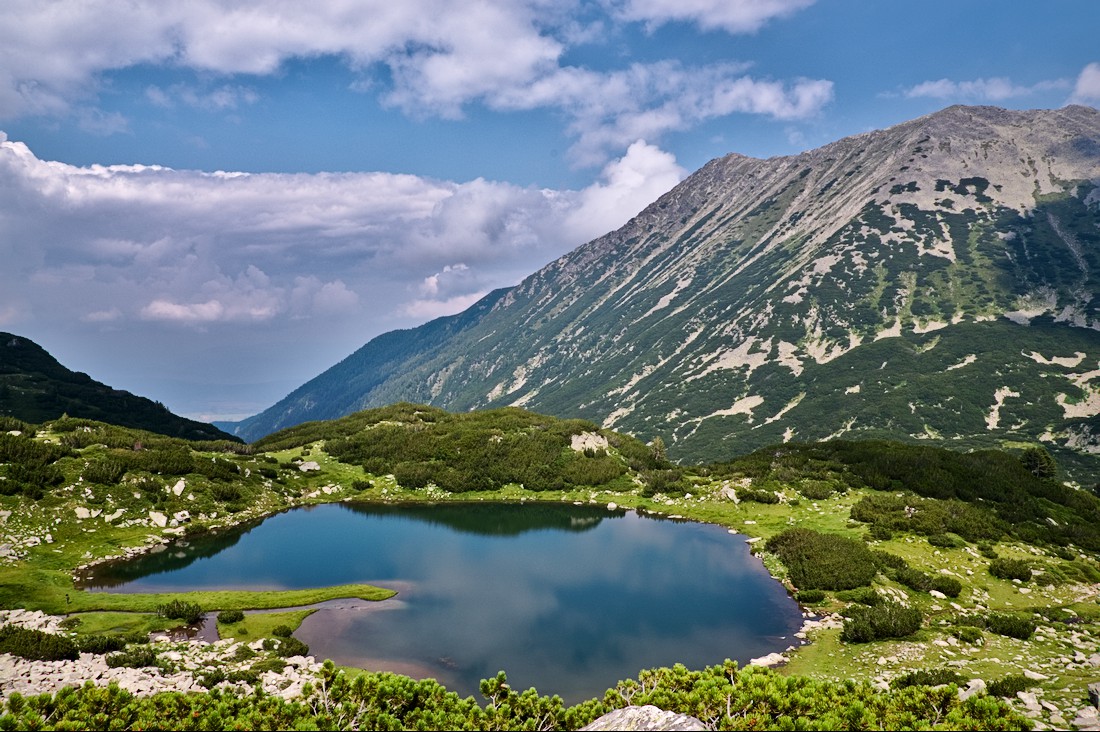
[84,503,802,703]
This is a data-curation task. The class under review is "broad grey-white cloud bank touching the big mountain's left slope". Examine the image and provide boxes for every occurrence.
[0,132,684,332]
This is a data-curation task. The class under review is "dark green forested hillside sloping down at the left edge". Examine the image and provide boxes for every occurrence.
[0,332,237,440]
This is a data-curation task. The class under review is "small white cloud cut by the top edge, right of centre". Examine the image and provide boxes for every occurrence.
[619,0,815,33]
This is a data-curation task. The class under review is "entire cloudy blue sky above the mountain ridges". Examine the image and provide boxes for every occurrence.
[0,0,1100,418]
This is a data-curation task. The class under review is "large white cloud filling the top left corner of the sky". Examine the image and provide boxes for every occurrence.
[0,0,562,116]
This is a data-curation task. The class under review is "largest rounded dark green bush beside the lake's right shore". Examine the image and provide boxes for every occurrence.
[765,528,878,590]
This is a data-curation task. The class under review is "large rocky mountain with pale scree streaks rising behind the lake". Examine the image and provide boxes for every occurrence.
[223,107,1100,468]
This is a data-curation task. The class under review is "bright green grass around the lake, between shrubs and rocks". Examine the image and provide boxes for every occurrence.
[0,407,1100,722]
